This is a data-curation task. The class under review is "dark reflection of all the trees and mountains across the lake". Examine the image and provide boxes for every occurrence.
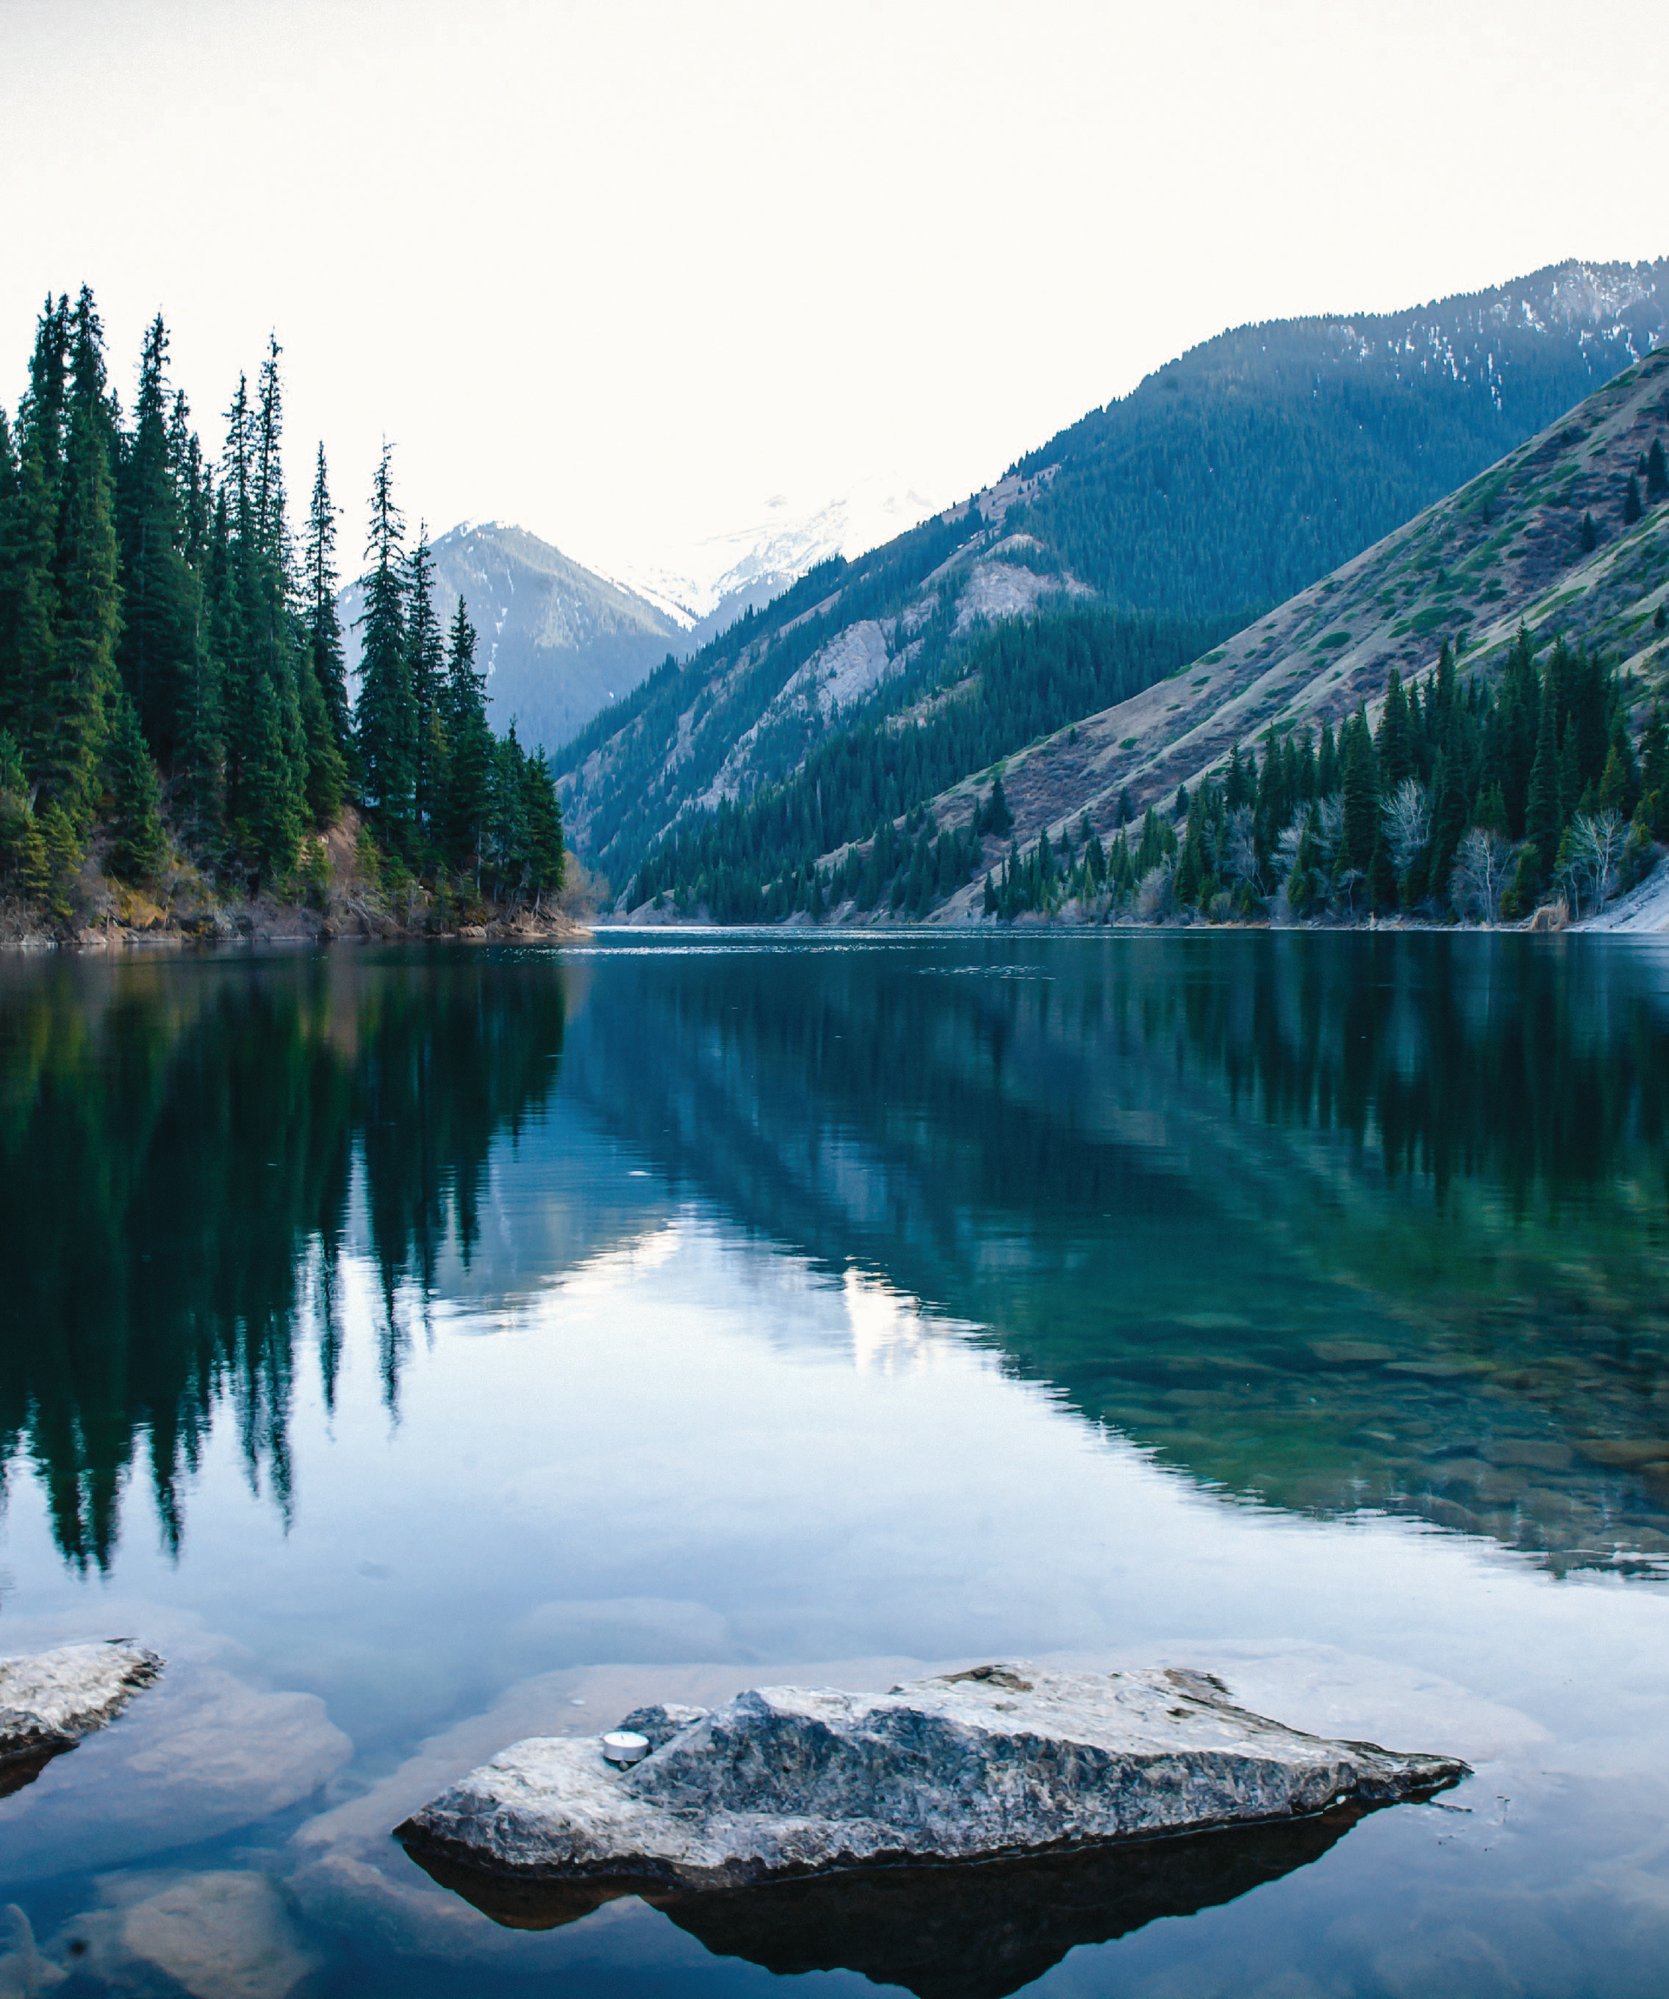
[0,936,1669,1575]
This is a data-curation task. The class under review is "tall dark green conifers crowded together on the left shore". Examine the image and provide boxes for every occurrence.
[0,288,566,928]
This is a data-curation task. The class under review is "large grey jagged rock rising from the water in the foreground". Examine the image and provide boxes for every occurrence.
[398,1665,1467,1889]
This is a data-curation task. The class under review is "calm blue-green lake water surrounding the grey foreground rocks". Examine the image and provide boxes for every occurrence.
[0,934,1669,1999]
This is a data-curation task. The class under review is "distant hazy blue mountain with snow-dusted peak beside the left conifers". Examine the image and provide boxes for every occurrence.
[340,522,684,748]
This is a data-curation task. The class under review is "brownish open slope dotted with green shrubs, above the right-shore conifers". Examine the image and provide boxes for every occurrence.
[931,350,1669,918]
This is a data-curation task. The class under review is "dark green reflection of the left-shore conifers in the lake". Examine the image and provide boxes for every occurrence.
[0,954,566,1567]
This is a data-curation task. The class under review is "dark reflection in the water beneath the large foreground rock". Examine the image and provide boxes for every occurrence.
[414,1809,1361,1999]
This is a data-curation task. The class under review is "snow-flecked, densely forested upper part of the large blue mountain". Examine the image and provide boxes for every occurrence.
[1015,260,1669,612]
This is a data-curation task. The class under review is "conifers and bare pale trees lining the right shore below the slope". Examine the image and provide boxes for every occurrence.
[983,632,1669,924]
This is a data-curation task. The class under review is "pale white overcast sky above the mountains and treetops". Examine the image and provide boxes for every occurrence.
[0,0,1669,566]
